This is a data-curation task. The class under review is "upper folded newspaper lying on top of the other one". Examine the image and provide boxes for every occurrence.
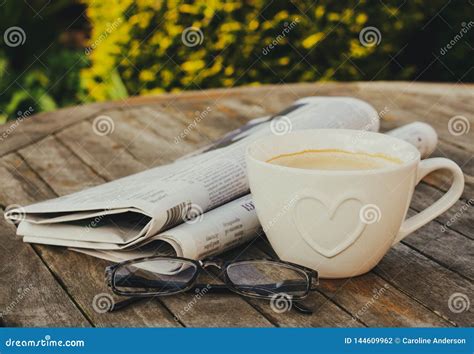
[11,97,379,254]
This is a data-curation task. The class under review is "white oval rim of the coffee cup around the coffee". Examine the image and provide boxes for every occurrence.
[245,129,421,175]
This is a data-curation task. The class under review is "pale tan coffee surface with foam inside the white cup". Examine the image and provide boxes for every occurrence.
[267,149,402,171]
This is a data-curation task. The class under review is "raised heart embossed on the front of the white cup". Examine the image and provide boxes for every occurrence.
[292,195,366,258]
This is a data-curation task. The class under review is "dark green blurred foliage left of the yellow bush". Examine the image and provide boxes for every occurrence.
[0,0,87,123]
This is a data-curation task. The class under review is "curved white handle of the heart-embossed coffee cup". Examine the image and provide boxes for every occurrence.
[392,157,464,245]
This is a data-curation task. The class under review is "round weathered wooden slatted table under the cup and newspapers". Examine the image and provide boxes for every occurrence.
[0,82,474,327]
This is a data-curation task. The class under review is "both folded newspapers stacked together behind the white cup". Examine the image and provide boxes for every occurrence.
[6,97,437,261]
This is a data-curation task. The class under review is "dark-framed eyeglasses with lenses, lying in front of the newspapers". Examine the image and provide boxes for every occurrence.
[105,256,318,313]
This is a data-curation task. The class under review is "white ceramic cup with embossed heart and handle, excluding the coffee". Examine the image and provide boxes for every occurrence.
[246,129,464,278]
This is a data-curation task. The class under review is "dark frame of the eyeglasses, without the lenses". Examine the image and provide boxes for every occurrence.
[105,256,319,300]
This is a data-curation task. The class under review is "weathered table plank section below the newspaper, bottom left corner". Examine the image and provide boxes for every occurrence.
[0,213,90,327]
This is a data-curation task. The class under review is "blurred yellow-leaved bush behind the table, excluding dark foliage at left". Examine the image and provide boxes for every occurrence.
[82,0,474,100]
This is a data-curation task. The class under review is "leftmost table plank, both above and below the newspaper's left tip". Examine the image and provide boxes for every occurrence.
[0,155,90,326]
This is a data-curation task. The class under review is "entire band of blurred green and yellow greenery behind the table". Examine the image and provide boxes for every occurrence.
[0,0,474,122]
